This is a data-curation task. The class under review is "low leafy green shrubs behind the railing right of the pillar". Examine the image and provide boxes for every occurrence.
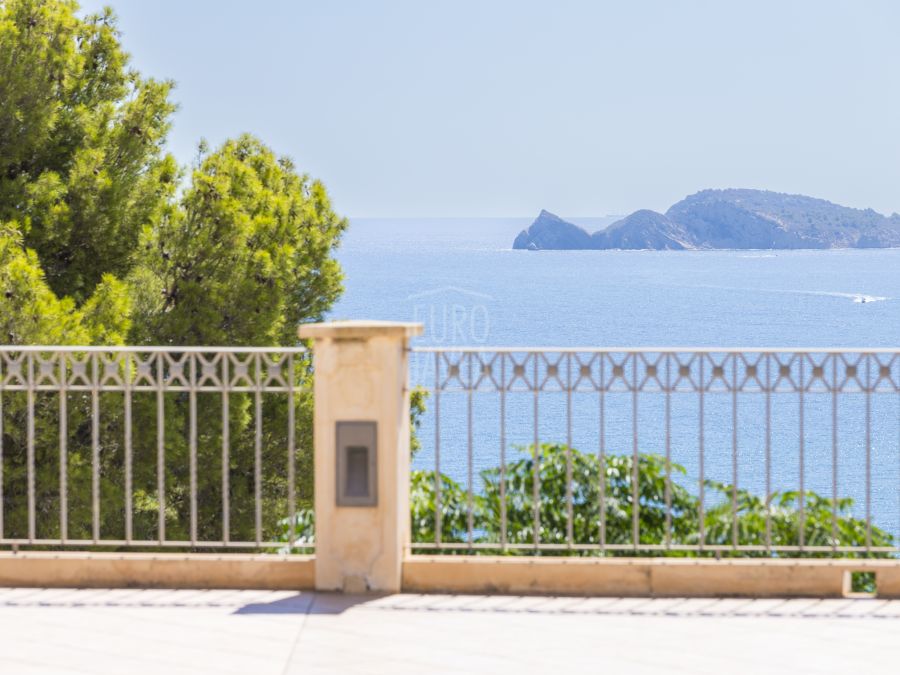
[411,444,893,556]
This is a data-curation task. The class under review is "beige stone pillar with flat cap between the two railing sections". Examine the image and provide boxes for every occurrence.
[300,321,422,593]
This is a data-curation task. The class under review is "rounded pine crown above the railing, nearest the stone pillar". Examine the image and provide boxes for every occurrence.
[134,135,345,345]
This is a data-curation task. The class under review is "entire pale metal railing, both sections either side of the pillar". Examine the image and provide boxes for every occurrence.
[0,344,900,556]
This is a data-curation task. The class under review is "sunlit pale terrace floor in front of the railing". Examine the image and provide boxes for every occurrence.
[0,588,900,675]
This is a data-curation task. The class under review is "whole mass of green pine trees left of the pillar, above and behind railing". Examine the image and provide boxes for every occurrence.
[0,0,346,540]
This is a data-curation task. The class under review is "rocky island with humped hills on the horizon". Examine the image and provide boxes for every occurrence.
[513,189,900,251]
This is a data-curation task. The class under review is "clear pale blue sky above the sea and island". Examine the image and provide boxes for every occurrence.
[83,0,900,217]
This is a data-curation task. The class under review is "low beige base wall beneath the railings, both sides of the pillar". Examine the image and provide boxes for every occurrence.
[0,552,900,598]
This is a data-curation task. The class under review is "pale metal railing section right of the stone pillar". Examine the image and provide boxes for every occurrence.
[410,348,900,556]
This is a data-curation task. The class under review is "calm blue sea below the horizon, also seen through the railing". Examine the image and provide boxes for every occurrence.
[331,219,900,544]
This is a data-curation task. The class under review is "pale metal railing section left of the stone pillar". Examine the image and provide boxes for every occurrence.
[0,346,312,550]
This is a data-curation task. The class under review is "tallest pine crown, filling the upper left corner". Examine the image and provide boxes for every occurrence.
[0,0,178,303]
